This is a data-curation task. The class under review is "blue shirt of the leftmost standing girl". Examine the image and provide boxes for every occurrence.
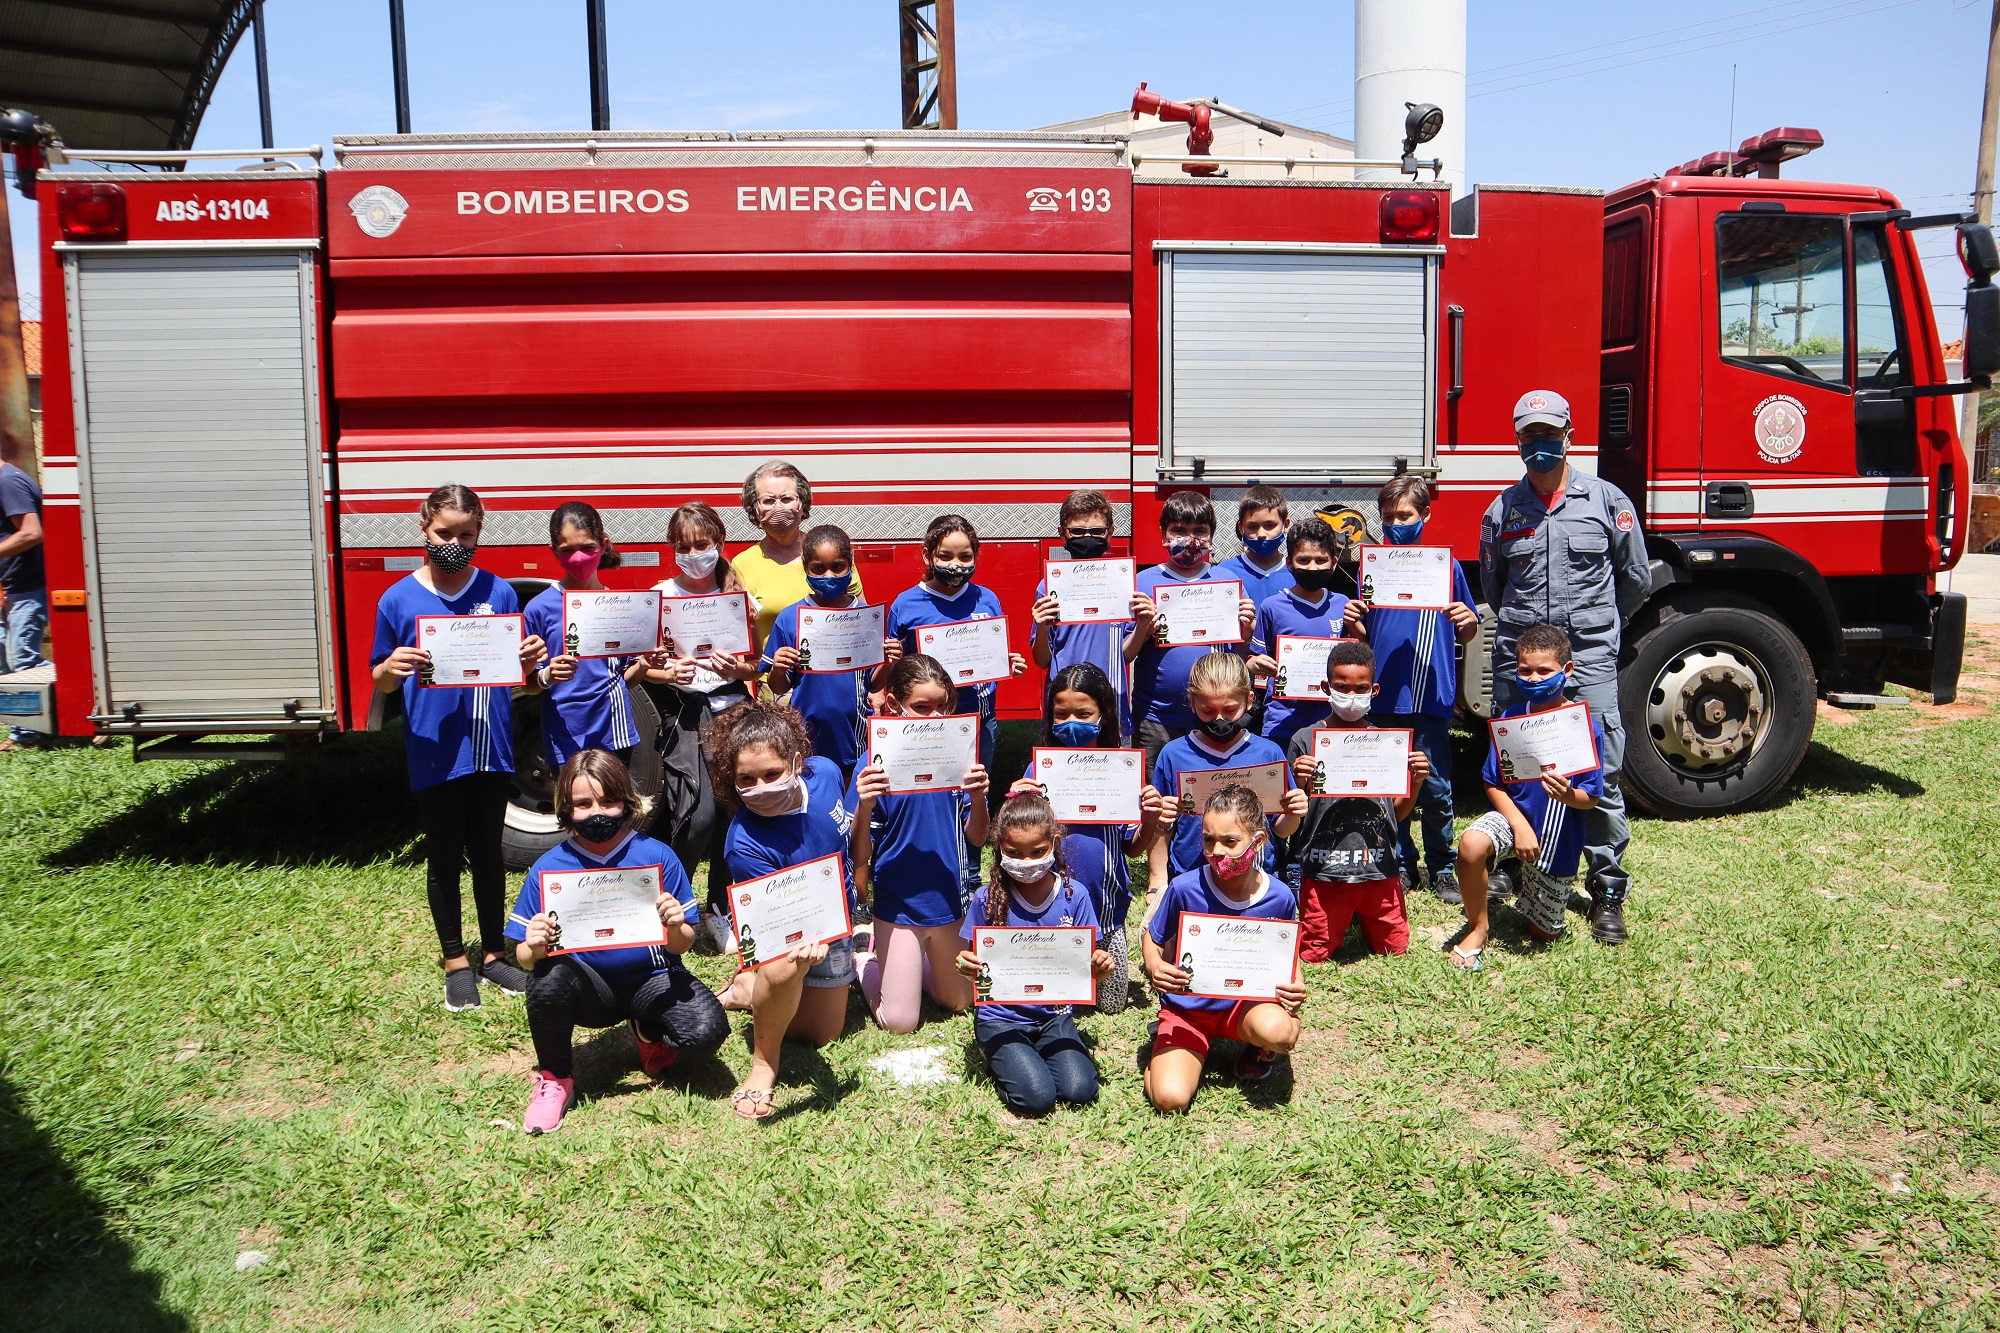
[368,570,532,791]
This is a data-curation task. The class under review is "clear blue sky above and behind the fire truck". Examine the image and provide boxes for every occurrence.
[14,0,1990,336]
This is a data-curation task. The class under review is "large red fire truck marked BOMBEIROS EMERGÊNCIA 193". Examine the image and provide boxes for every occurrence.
[38,111,2000,860]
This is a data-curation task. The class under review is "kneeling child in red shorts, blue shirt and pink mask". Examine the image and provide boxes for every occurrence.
[1140,785,1306,1113]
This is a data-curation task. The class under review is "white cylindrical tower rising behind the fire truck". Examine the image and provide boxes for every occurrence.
[1354,0,1466,196]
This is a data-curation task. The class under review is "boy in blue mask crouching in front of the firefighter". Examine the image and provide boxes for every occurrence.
[1452,624,1604,971]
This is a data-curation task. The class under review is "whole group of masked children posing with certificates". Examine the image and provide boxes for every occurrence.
[372,476,1602,1133]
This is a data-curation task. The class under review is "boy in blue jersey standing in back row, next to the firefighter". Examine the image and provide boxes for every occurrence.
[1346,472,1480,903]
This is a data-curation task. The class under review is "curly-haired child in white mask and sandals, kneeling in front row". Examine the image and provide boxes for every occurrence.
[708,699,854,1121]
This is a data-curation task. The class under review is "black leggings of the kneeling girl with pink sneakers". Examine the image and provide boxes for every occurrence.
[528,955,730,1079]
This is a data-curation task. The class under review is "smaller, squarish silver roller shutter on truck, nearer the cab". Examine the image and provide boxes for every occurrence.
[1160,250,1434,478]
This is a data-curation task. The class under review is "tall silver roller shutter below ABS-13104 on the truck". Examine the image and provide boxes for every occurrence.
[64,248,336,733]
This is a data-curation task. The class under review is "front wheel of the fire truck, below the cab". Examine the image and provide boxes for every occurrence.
[1618,590,1818,819]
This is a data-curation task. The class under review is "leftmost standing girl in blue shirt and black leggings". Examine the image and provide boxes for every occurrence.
[368,486,548,1013]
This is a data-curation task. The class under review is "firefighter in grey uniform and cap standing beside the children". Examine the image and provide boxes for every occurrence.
[1480,388,1652,945]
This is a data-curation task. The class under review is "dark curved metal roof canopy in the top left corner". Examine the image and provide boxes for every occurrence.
[0,0,254,150]
